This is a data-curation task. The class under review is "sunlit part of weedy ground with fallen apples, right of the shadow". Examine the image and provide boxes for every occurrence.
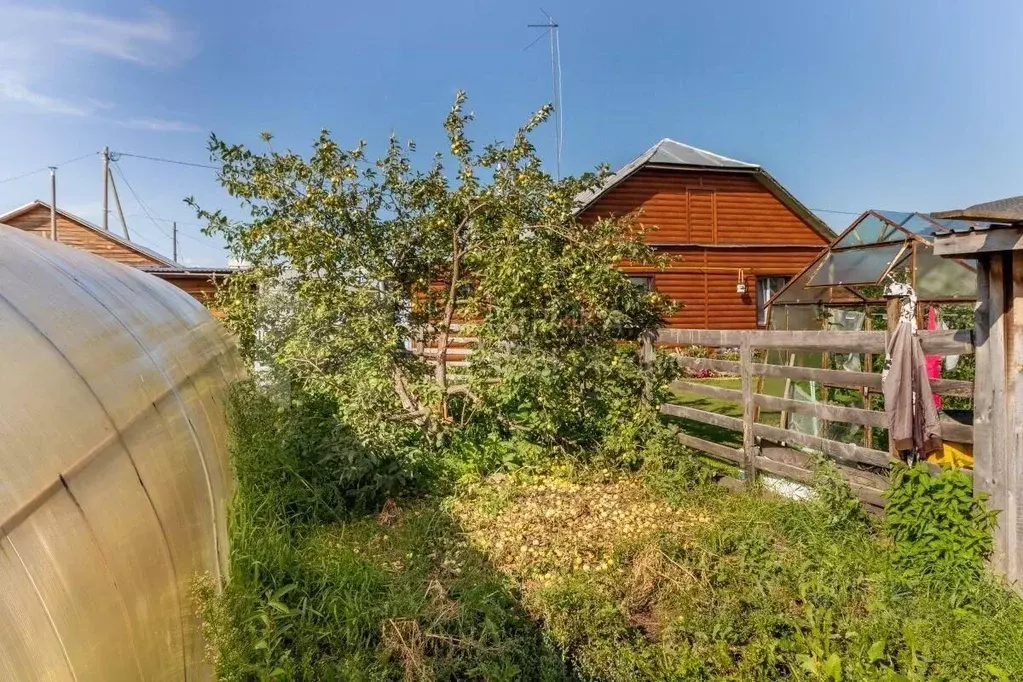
[454,475,1023,680]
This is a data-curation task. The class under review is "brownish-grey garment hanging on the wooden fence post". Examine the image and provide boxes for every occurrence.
[881,283,942,458]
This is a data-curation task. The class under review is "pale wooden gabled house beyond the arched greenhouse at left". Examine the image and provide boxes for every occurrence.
[0,199,232,304]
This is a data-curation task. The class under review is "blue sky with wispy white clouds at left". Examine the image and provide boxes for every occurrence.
[0,0,1023,264]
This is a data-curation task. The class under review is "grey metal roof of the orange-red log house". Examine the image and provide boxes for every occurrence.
[576,137,835,240]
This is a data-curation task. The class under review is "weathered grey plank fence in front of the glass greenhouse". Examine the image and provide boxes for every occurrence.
[646,329,974,507]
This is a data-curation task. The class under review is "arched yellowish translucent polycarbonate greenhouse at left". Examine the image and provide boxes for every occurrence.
[0,226,242,680]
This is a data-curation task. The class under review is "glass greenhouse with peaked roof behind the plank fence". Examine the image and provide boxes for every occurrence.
[760,211,983,456]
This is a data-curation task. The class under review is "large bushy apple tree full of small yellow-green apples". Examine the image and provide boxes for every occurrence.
[189,93,669,458]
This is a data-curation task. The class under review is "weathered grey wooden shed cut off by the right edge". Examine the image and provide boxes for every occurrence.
[934,196,1023,587]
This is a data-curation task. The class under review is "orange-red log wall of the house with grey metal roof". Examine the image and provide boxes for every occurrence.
[582,169,828,329]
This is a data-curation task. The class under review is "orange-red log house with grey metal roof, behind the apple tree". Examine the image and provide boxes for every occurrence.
[579,138,835,329]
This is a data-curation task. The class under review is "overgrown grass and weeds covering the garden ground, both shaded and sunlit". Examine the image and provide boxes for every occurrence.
[201,384,1023,682]
